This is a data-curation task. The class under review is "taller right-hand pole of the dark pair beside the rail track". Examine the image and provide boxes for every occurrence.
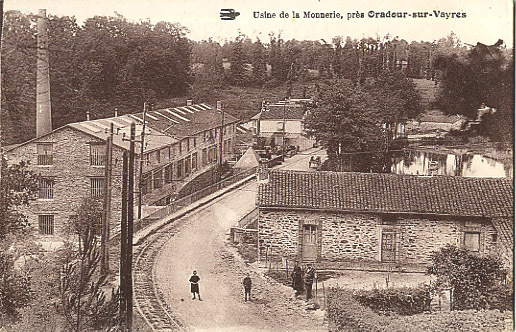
[126,123,136,332]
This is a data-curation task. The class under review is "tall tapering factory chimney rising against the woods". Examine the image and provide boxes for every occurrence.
[36,9,52,137]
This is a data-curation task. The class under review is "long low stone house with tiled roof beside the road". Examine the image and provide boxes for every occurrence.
[257,171,514,272]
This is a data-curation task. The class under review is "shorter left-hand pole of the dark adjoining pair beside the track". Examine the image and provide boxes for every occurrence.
[120,151,128,330]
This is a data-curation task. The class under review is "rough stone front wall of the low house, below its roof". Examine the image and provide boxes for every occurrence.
[258,208,499,265]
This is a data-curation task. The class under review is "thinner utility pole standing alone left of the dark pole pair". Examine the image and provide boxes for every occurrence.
[100,122,114,275]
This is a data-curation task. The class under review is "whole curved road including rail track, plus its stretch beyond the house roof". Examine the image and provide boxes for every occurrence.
[135,149,327,331]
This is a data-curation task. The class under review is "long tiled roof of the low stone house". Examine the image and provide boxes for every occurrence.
[258,171,514,217]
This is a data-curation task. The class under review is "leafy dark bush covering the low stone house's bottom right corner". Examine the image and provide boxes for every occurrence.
[427,245,512,310]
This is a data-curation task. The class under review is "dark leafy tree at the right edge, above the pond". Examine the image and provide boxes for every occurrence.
[434,40,514,142]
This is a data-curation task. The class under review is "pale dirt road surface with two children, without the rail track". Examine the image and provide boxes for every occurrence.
[156,182,327,332]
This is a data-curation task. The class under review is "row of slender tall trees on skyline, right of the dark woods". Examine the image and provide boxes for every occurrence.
[193,33,466,92]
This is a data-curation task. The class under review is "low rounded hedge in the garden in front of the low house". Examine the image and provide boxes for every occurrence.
[355,285,432,315]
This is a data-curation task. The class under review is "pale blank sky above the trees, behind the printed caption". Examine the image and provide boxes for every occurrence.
[5,0,514,47]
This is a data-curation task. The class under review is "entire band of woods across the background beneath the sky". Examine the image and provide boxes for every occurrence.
[2,11,512,144]
